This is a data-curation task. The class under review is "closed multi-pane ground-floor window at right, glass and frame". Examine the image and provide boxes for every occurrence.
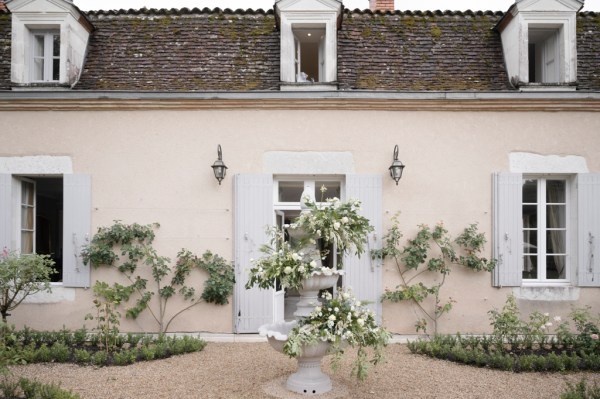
[523,177,570,282]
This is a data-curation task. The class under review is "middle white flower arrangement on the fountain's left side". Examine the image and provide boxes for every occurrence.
[246,228,343,289]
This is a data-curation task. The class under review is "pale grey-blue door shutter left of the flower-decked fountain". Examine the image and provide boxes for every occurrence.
[234,174,274,333]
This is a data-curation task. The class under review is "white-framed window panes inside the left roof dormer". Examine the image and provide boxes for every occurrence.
[31,31,60,82]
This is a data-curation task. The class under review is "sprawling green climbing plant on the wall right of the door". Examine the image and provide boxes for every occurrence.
[371,215,496,334]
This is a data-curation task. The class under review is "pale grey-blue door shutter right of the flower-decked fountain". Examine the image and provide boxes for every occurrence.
[344,175,383,322]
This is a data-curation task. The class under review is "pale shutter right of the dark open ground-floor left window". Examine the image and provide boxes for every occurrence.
[63,174,92,288]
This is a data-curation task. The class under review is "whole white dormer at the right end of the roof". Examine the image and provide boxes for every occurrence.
[496,0,583,90]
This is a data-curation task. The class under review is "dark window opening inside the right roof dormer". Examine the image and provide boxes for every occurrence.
[528,26,560,83]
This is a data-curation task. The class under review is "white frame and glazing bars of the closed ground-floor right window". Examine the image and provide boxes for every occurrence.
[521,175,576,286]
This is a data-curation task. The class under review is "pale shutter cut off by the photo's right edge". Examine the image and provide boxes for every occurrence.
[577,173,600,287]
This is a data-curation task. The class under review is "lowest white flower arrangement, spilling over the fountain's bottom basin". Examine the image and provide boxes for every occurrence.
[283,291,390,380]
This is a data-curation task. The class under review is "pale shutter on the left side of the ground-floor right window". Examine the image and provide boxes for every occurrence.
[492,173,523,287]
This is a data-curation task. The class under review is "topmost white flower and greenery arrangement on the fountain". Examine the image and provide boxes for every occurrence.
[290,195,373,255]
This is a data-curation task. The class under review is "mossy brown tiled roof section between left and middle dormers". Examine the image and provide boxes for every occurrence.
[76,9,279,91]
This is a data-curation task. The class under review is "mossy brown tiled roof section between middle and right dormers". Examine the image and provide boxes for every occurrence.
[338,11,511,91]
